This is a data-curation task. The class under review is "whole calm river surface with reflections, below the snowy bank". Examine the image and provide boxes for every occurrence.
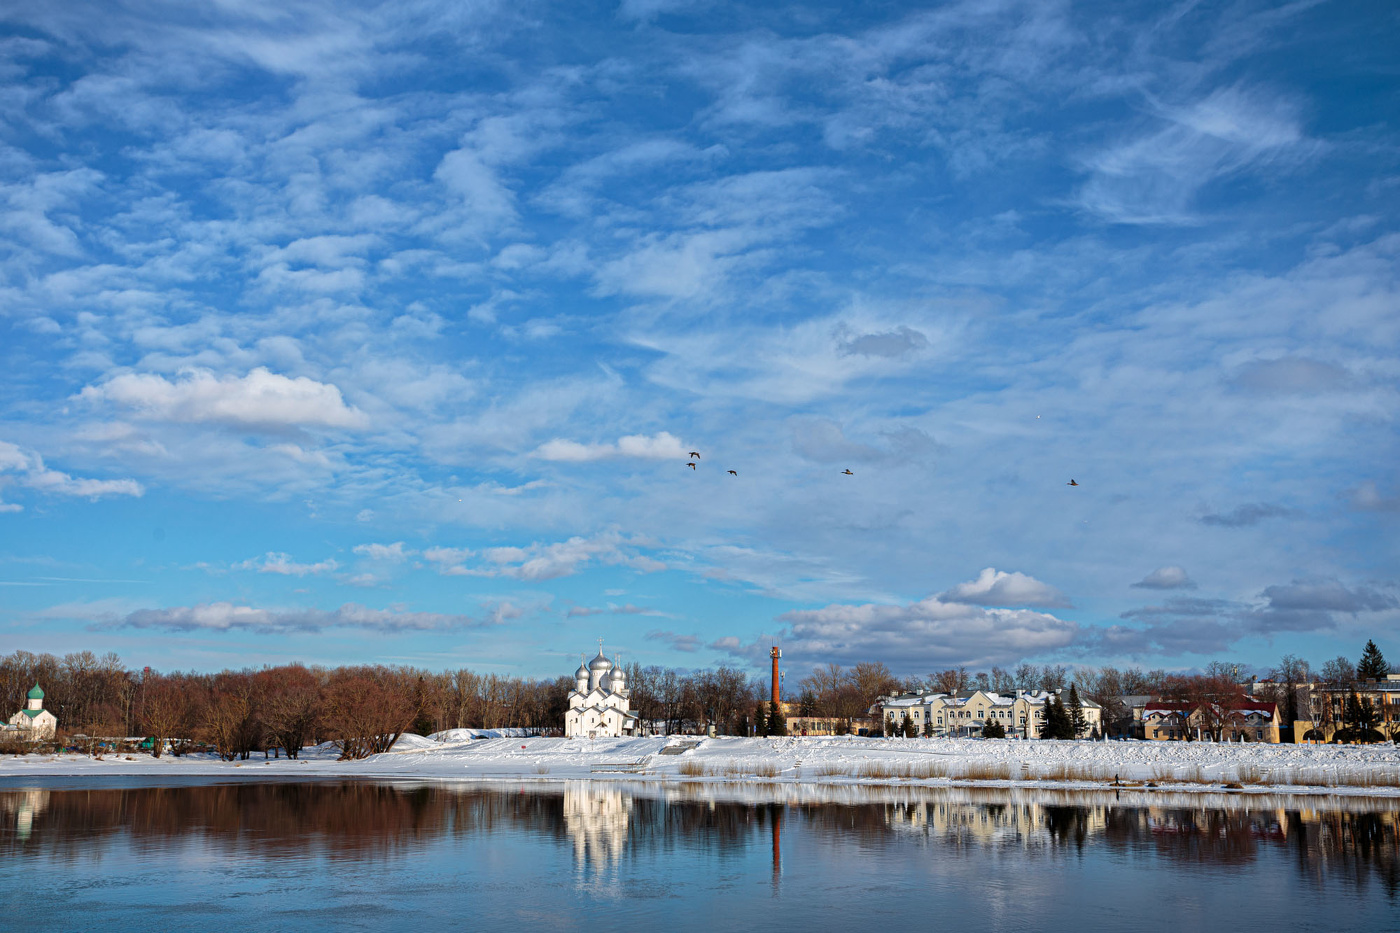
[0,779,1400,933]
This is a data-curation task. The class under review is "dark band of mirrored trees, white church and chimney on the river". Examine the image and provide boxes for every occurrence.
[0,782,1400,926]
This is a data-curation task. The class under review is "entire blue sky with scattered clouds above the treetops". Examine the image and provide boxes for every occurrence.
[0,0,1400,675]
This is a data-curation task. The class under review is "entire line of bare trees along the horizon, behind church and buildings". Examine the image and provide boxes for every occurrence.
[8,642,1390,759]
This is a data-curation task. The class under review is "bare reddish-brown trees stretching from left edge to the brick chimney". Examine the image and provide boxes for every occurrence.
[0,651,784,761]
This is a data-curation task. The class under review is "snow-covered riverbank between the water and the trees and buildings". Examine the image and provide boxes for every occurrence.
[0,730,1400,797]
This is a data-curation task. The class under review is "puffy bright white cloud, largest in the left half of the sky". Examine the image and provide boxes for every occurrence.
[81,367,368,429]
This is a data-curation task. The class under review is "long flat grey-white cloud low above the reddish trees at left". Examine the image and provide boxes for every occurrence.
[112,602,483,633]
